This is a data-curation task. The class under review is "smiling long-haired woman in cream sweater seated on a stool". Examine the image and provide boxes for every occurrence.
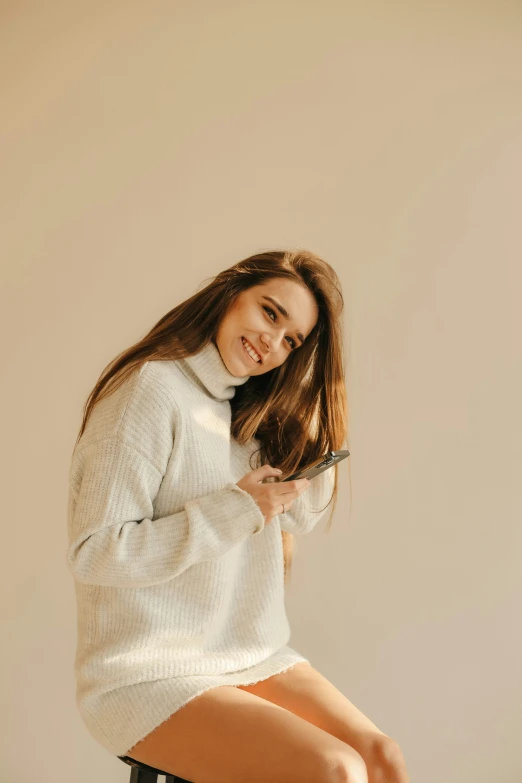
[67,250,407,783]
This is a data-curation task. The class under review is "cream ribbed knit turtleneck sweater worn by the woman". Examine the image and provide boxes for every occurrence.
[67,342,333,755]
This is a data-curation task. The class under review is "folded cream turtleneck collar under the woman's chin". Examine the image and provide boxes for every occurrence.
[177,340,250,400]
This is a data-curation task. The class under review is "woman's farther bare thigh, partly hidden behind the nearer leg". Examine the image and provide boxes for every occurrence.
[237,662,386,761]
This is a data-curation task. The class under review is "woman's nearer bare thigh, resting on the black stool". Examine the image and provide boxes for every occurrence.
[127,686,368,783]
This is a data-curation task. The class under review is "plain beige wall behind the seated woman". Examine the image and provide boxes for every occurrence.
[0,0,522,783]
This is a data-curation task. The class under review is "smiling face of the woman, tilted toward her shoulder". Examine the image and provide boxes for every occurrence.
[215,278,319,377]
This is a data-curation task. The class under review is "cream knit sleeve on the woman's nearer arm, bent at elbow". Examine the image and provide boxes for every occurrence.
[67,436,265,587]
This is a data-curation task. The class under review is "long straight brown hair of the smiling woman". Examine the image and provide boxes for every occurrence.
[76,249,348,583]
